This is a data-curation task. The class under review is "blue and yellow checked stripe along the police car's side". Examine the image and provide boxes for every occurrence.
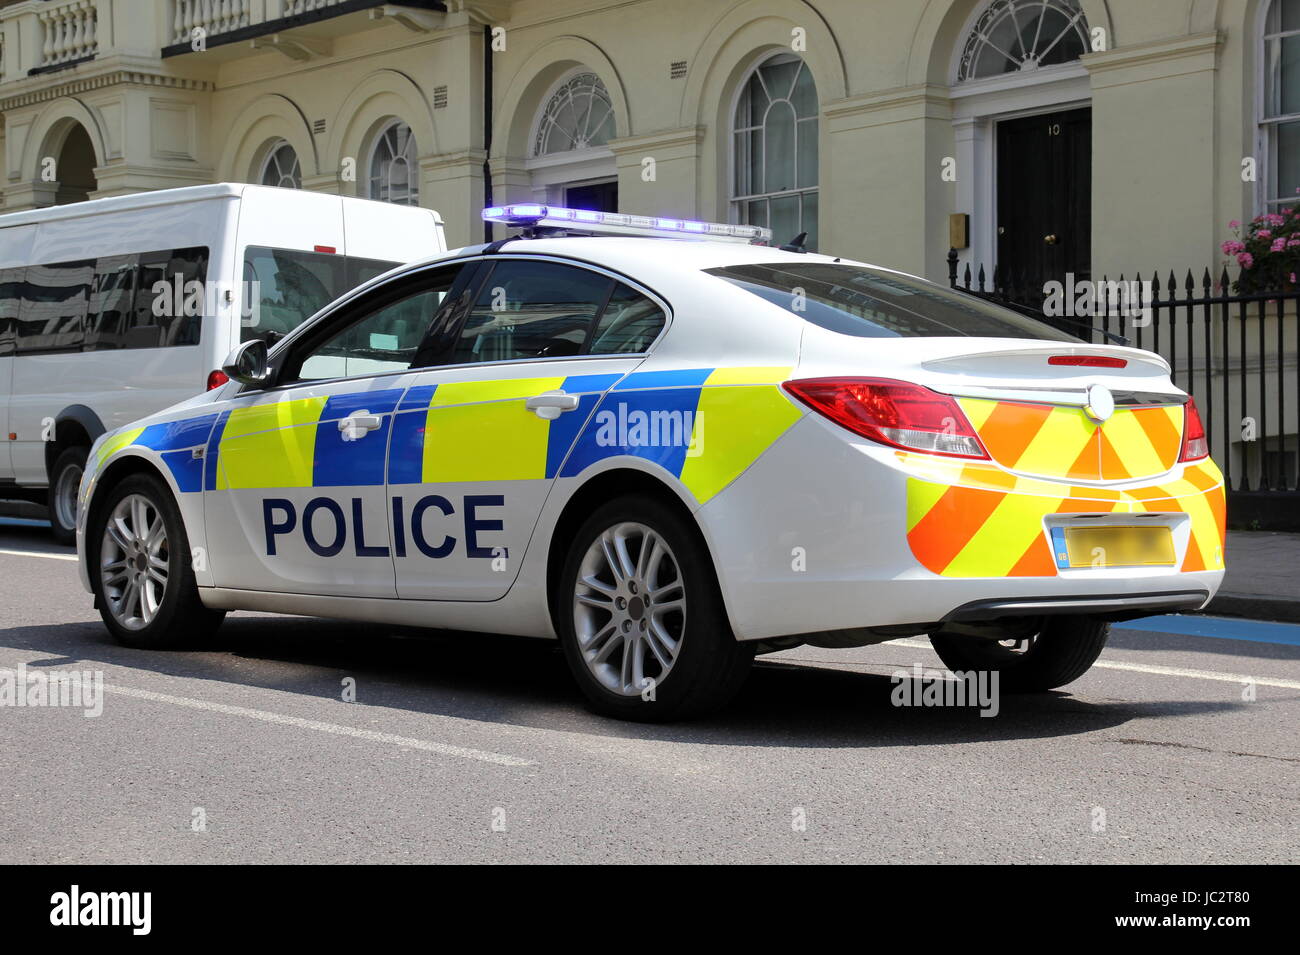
[100,368,802,503]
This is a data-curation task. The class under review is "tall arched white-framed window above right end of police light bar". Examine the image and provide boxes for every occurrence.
[732,53,818,249]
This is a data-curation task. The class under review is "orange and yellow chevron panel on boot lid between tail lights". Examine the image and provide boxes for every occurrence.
[957,398,1183,481]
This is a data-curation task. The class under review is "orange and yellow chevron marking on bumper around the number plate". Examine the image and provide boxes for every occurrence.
[897,452,1226,577]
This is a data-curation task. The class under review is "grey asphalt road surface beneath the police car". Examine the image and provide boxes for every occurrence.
[0,521,1300,864]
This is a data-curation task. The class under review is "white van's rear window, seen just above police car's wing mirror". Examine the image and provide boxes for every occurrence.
[239,246,400,342]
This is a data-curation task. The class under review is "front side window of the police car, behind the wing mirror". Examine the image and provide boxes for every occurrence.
[280,266,460,383]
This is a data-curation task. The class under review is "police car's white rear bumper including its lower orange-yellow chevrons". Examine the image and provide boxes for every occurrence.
[697,414,1223,639]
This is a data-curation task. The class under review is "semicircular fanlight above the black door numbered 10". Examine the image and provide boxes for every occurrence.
[957,0,1088,81]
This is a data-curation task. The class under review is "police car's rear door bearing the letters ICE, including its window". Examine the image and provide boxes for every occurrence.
[389,256,667,600]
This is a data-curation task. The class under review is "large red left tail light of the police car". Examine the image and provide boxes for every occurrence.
[785,378,988,459]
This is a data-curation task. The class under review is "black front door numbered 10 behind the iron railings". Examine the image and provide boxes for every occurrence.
[997,103,1092,304]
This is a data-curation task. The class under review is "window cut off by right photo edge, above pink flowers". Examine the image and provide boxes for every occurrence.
[1260,0,1300,212]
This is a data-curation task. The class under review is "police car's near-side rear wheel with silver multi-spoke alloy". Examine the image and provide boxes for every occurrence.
[554,495,754,722]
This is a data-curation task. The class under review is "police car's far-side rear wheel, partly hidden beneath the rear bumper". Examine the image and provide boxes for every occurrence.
[930,616,1110,693]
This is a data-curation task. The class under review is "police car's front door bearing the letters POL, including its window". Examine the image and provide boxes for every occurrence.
[204,266,470,598]
